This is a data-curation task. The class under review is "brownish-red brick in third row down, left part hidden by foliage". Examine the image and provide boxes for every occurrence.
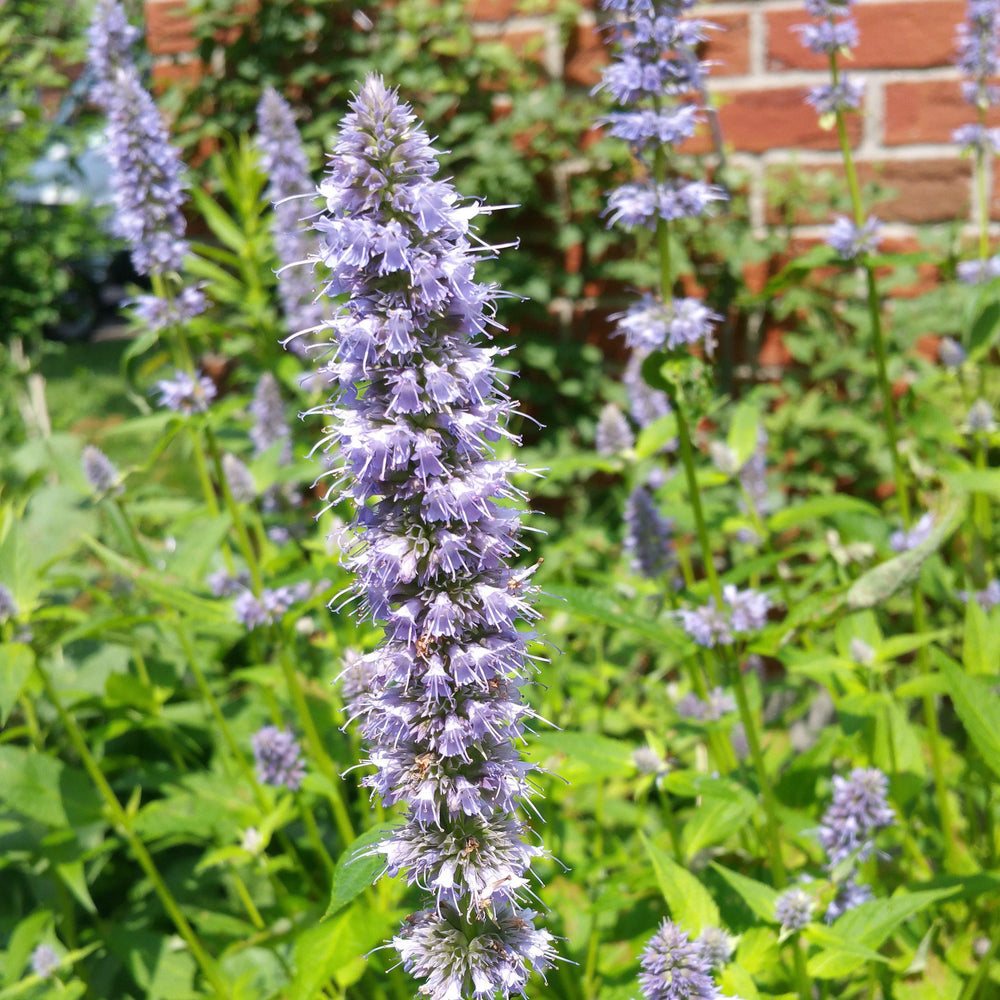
[766,157,971,224]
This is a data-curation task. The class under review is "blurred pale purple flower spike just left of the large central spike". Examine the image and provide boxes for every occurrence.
[257,87,324,334]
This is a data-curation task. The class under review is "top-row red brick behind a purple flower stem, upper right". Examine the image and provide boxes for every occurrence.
[767,0,965,69]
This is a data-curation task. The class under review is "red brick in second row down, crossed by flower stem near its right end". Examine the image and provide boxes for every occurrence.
[683,87,861,153]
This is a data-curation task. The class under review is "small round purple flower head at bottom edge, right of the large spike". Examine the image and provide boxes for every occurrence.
[639,920,731,1000]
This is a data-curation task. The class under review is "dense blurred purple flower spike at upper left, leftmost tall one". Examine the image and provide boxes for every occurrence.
[107,64,188,274]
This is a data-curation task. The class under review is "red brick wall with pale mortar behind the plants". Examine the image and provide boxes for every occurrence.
[146,0,988,235]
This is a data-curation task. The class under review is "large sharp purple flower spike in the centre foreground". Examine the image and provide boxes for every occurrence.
[316,75,554,1000]
